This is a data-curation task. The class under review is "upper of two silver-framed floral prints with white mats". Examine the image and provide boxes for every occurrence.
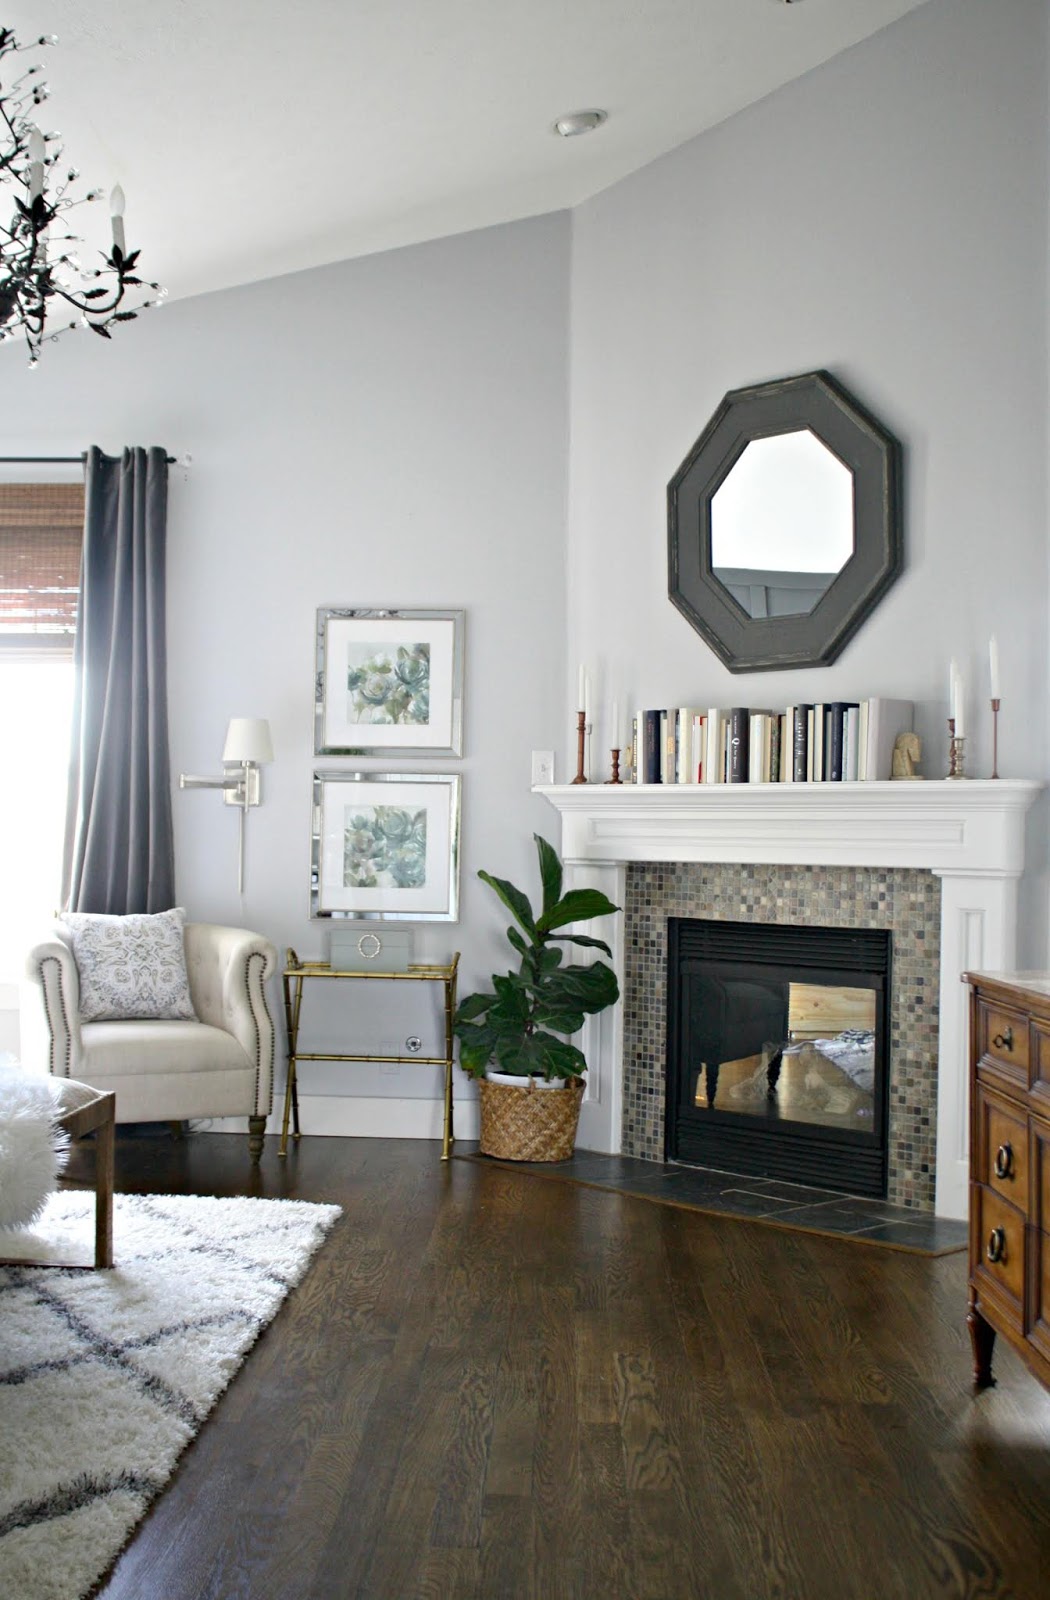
[314,606,463,755]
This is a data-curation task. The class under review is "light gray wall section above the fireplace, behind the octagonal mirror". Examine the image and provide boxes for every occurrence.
[563,0,1048,960]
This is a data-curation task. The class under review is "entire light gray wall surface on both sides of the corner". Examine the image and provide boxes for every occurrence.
[8,0,1050,1131]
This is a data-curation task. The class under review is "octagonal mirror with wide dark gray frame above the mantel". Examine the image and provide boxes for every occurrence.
[667,373,901,672]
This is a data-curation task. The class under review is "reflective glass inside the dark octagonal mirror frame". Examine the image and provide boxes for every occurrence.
[711,427,855,618]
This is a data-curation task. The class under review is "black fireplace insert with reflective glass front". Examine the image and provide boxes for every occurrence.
[667,918,890,1195]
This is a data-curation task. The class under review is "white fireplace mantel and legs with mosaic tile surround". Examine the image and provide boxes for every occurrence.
[538,779,1040,1218]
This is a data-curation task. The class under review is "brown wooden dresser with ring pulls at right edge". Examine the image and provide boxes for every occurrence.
[964,973,1050,1387]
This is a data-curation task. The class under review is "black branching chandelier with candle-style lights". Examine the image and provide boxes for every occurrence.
[0,27,166,366]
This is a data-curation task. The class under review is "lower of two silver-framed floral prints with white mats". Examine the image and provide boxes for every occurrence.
[311,773,459,922]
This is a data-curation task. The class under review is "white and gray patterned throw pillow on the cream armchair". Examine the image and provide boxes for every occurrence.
[61,906,197,1022]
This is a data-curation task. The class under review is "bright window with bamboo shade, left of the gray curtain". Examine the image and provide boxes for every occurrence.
[0,482,83,984]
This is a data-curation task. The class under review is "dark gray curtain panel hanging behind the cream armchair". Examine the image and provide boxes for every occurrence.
[62,446,174,914]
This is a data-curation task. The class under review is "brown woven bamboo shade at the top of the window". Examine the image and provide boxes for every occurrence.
[0,483,83,656]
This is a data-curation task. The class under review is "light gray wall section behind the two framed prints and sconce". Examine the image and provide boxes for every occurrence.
[0,214,568,1107]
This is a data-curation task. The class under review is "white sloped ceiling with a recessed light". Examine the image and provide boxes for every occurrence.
[2,0,922,298]
